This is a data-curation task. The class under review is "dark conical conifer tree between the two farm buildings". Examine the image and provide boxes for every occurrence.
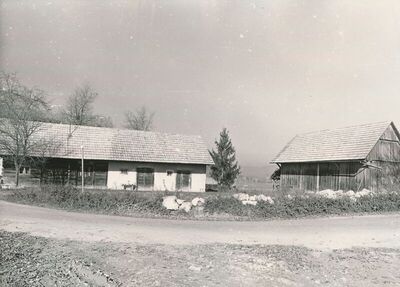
[210,128,240,188]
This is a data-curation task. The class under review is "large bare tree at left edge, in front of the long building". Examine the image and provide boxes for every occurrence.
[0,73,48,186]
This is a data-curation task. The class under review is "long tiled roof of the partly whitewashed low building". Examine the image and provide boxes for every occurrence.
[26,123,213,164]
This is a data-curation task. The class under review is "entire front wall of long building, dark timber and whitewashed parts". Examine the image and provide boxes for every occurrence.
[2,159,206,192]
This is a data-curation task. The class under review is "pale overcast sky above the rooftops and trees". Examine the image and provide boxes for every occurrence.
[0,0,400,166]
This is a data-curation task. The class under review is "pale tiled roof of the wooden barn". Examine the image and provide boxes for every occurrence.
[272,121,398,163]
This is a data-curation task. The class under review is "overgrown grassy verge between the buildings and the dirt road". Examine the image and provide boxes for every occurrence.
[1,186,400,219]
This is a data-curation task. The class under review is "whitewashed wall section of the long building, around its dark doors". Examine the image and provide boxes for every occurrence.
[107,161,206,192]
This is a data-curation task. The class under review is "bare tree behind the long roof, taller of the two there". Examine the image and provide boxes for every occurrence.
[64,84,97,126]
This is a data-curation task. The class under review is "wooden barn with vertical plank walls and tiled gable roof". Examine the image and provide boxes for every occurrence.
[272,122,400,191]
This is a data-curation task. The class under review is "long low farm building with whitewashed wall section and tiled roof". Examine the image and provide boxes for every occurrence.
[3,123,213,191]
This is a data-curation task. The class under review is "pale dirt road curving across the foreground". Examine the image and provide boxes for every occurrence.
[0,201,400,250]
